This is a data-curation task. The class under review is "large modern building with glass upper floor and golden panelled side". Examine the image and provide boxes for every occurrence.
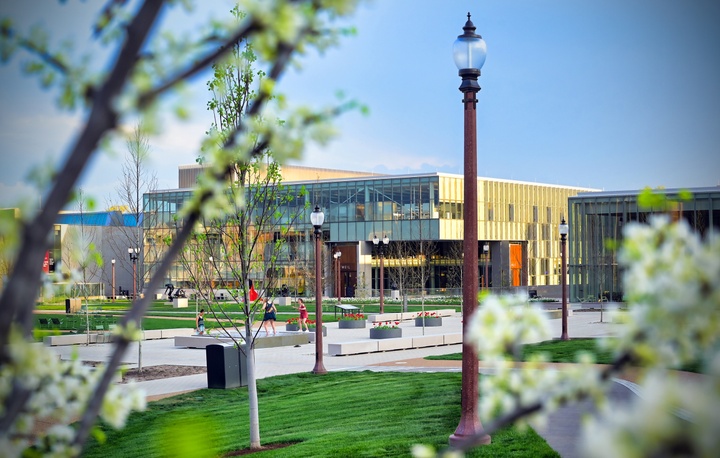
[143,165,597,297]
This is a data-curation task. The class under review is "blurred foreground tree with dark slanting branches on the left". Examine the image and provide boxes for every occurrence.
[0,0,355,455]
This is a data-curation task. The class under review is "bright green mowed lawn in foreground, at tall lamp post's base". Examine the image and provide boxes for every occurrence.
[83,372,558,458]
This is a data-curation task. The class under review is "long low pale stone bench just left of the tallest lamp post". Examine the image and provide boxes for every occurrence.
[328,332,462,356]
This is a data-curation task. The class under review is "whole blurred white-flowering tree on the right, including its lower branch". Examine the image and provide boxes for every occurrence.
[415,216,720,457]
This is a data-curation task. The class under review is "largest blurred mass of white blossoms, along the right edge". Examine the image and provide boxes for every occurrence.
[583,217,720,457]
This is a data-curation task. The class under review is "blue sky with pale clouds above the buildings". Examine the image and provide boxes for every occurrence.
[0,0,720,206]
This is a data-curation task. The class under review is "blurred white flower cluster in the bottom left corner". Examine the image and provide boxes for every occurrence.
[0,330,146,457]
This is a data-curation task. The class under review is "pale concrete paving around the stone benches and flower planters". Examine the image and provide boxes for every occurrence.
[47,305,630,458]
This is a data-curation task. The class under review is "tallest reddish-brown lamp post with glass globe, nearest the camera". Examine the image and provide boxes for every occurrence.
[450,13,490,445]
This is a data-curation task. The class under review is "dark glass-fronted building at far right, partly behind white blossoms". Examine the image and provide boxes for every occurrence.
[568,187,720,301]
